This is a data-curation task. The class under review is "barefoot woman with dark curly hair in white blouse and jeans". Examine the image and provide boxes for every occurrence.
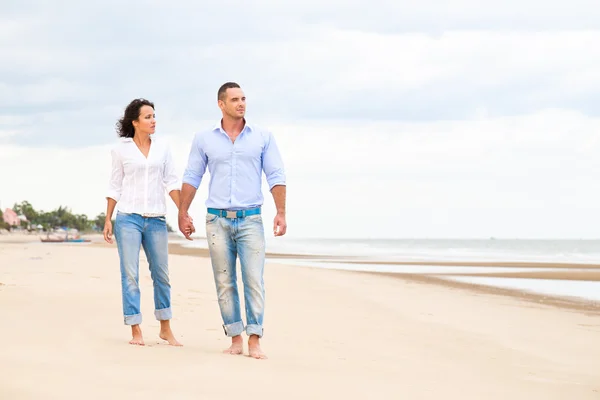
[104,99,181,346]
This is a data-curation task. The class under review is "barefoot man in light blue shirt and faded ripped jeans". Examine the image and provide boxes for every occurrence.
[179,82,287,359]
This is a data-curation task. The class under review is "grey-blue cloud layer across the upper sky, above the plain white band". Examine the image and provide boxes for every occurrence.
[0,0,600,146]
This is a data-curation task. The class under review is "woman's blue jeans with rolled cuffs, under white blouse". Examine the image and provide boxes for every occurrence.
[114,212,172,325]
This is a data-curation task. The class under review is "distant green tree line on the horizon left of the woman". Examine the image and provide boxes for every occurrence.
[0,201,173,233]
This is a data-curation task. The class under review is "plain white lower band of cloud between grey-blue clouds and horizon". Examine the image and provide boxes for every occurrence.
[0,110,600,238]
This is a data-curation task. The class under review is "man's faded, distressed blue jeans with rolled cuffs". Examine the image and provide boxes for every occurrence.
[206,214,265,337]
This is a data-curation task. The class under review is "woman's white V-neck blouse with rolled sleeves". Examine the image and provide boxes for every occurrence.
[107,138,181,216]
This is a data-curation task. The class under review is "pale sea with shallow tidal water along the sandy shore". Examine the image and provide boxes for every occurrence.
[177,237,600,303]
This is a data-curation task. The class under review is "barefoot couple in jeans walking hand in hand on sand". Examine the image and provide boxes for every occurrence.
[104,82,287,359]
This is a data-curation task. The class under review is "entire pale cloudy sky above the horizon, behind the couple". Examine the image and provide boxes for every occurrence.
[0,0,600,238]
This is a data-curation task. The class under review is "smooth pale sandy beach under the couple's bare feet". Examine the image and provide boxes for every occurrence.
[0,235,600,400]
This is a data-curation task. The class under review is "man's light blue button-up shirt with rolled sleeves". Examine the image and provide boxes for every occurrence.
[182,121,286,210]
